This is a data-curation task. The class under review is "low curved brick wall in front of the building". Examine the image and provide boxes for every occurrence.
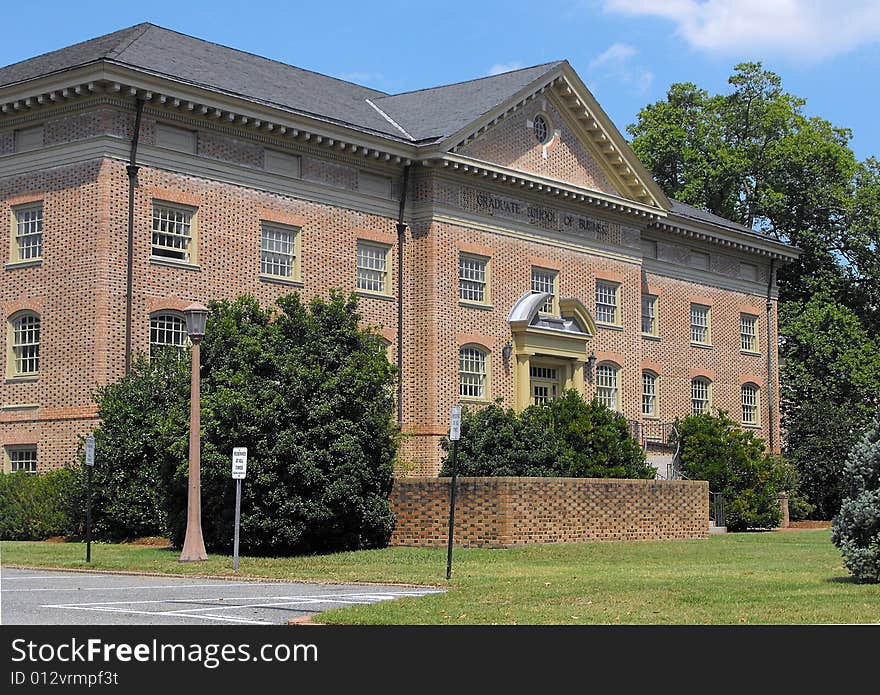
[390,478,709,548]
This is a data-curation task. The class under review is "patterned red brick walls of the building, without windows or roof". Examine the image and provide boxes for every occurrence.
[0,35,796,478]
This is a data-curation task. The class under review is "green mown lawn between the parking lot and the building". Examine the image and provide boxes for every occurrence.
[0,529,880,625]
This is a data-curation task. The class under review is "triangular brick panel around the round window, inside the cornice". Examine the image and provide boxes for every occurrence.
[458,96,625,195]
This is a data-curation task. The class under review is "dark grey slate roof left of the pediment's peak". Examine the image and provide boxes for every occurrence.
[0,23,559,142]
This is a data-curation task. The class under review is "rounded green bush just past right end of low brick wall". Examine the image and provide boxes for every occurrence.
[676,413,789,531]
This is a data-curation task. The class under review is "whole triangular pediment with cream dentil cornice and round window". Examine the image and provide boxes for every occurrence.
[442,62,670,210]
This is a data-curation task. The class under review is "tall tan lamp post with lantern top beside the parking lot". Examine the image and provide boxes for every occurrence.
[180,303,208,562]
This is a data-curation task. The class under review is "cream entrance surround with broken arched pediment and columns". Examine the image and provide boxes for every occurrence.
[507,292,596,410]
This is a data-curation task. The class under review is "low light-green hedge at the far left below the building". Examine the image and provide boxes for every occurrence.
[0,468,72,541]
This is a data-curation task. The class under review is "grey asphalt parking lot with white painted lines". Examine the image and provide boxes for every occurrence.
[0,568,442,625]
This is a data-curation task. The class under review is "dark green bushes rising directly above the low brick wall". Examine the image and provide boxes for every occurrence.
[440,391,655,478]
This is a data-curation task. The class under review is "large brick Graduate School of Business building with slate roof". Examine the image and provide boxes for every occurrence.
[0,24,797,475]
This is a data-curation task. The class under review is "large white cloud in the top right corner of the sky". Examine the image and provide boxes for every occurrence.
[600,0,880,61]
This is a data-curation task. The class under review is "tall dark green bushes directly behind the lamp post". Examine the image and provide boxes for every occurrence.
[81,294,397,554]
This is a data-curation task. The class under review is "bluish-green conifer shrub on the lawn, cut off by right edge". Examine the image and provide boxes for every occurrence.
[831,419,880,583]
